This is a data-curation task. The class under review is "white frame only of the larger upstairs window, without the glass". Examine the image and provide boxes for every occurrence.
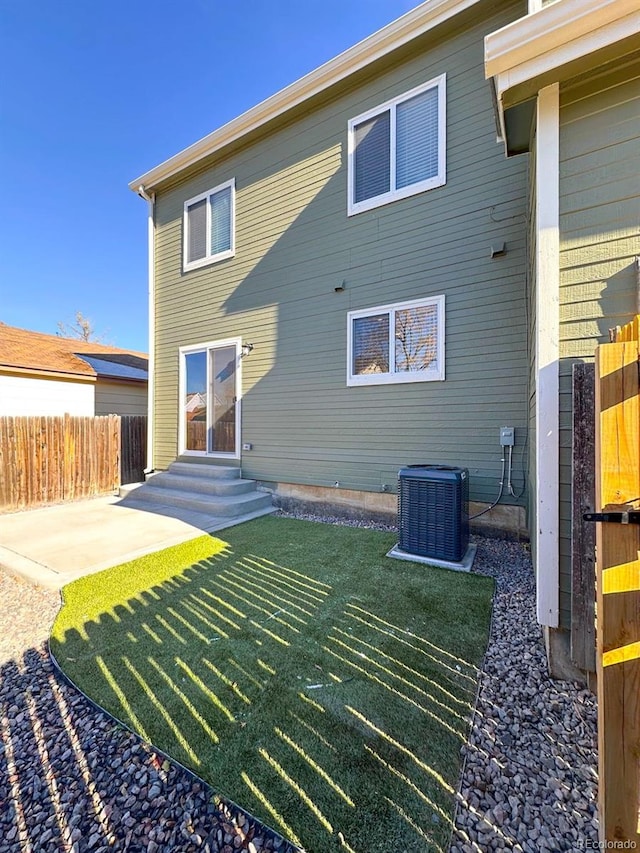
[347,74,447,216]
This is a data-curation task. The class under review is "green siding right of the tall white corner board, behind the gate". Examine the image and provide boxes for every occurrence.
[560,55,640,626]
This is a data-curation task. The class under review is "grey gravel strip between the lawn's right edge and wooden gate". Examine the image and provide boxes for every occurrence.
[450,537,598,853]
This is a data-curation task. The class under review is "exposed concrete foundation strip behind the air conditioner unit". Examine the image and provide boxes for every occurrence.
[258,481,529,541]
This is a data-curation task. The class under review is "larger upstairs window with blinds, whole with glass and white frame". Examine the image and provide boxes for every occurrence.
[347,74,446,216]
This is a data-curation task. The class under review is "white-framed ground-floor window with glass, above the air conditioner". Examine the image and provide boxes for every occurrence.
[347,296,444,385]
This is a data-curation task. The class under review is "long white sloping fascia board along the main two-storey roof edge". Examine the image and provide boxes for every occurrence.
[129,0,480,192]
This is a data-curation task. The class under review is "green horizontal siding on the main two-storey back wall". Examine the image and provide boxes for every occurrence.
[154,3,528,503]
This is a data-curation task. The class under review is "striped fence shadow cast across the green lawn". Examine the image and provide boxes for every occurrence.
[52,550,488,853]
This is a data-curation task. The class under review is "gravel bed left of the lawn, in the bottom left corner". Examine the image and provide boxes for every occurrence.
[0,571,295,853]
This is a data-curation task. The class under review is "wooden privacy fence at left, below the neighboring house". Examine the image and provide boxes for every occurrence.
[0,415,147,512]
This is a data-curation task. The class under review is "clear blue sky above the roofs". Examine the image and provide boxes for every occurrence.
[0,0,418,350]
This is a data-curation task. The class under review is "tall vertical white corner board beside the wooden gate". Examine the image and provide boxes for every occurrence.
[535,83,560,628]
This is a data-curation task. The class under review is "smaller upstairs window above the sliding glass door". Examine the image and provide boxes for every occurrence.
[183,178,236,271]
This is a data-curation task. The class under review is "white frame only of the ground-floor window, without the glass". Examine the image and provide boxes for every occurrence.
[347,295,445,387]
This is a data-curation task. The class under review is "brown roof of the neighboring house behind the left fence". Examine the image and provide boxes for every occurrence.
[0,322,149,381]
